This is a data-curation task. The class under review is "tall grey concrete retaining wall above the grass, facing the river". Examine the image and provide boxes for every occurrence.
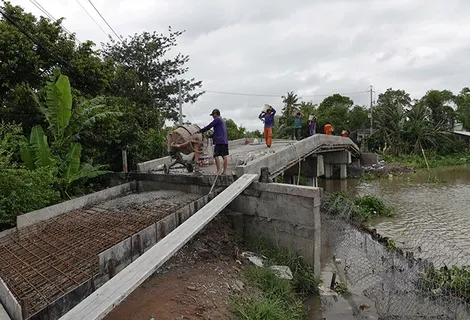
[228,182,321,276]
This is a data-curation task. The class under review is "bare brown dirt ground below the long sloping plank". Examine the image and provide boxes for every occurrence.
[105,215,245,320]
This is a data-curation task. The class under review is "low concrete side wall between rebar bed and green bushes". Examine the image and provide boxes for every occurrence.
[16,181,136,229]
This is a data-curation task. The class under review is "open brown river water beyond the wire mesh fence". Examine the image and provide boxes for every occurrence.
[322,165,470,265]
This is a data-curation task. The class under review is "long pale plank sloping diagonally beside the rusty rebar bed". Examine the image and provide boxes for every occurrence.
[60,174,258,320]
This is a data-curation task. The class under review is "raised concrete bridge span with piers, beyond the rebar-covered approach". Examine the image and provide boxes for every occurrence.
[137,134,360,183]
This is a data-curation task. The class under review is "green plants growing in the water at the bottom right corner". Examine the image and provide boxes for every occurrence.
[418,266,470,302]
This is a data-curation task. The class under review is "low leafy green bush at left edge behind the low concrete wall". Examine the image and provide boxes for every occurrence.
[0,169,60,231]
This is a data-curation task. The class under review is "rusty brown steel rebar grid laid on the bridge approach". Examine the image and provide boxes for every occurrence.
[0,205,190,316]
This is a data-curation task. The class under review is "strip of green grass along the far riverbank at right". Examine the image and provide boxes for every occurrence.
[383,152,470,169]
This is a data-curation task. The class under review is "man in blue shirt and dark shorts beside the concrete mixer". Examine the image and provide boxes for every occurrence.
[197,109,228,175]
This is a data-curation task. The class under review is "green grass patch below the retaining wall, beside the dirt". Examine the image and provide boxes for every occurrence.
[231,238,318,320]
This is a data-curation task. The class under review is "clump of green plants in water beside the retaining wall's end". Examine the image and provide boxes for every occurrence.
[323,191,395,223]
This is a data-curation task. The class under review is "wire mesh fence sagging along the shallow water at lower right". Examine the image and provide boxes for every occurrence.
[322,194,470,320]
